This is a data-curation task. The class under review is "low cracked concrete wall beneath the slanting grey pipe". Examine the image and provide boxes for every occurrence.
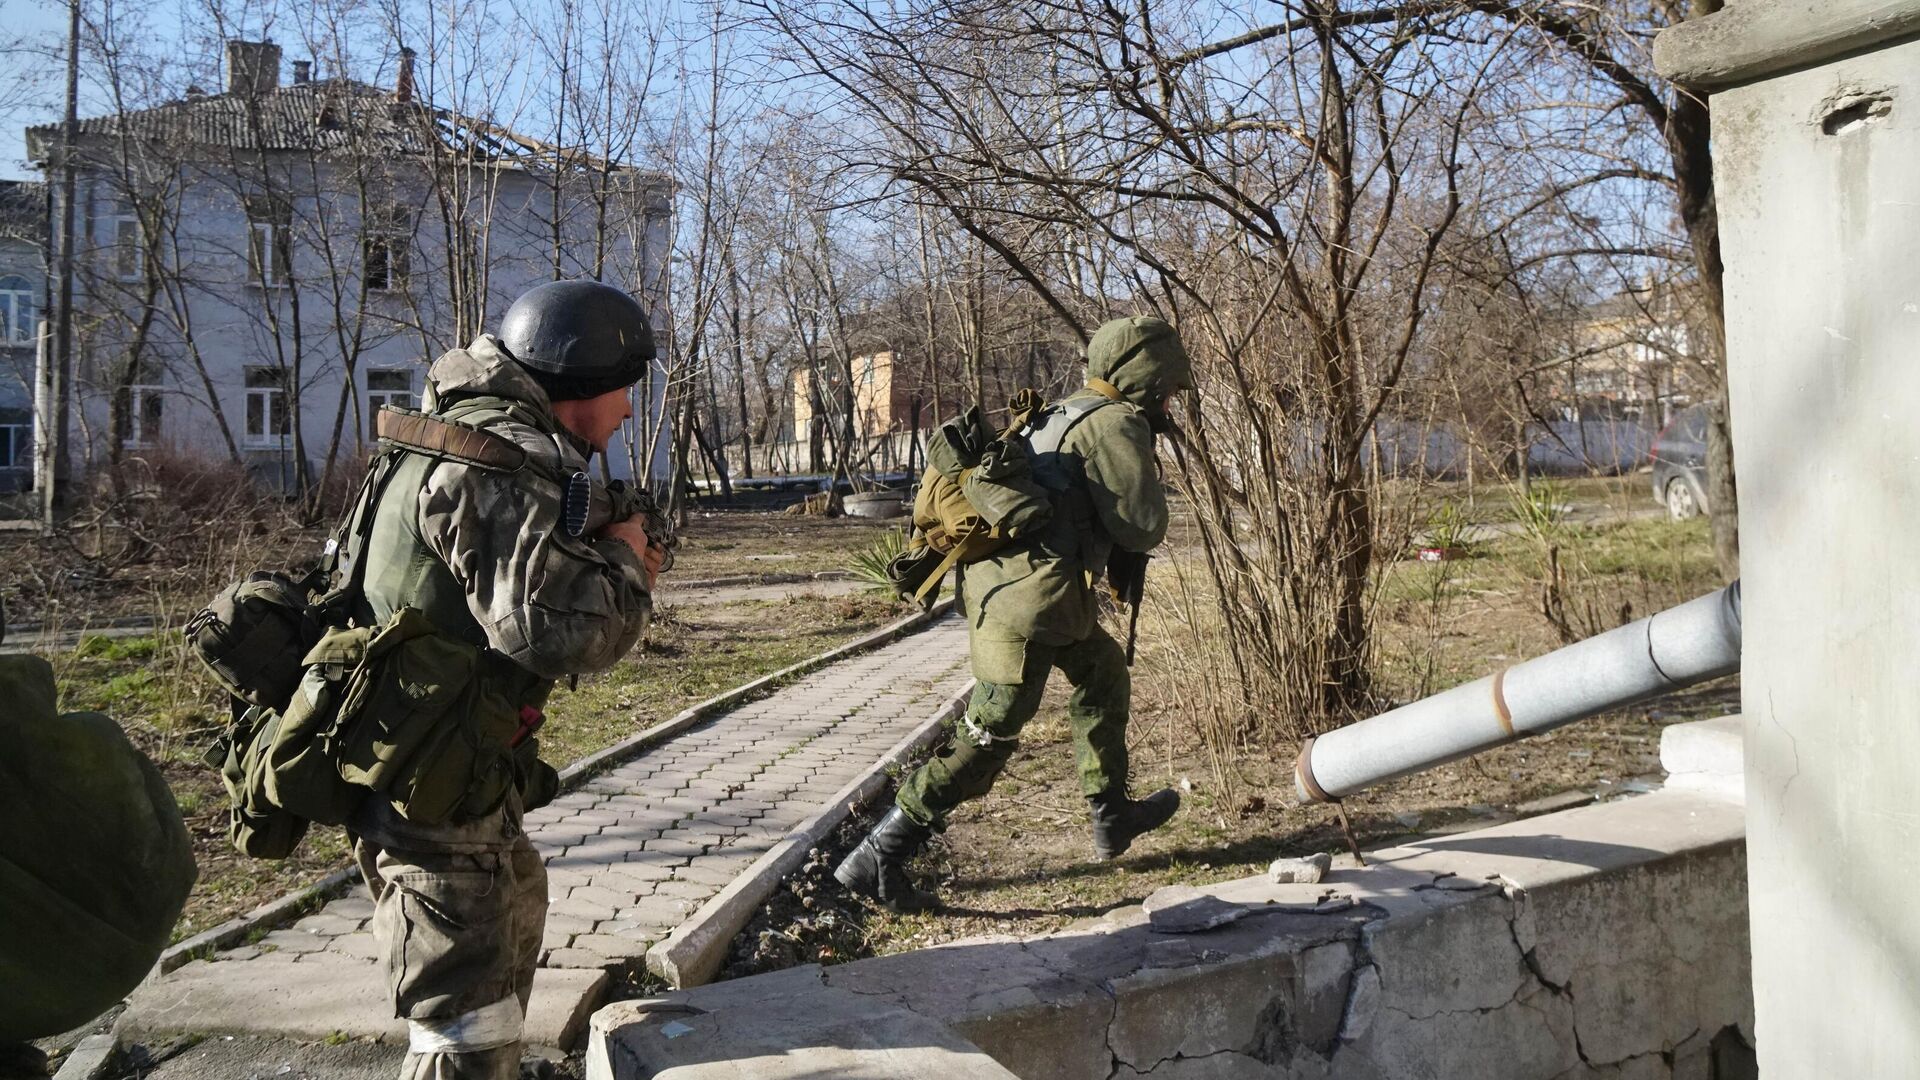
[588,776,1753,1080]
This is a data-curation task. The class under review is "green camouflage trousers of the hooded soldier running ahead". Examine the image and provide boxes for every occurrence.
[895,626,1133,828]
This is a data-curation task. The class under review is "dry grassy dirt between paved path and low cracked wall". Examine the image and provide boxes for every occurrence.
[730,477,1740,974]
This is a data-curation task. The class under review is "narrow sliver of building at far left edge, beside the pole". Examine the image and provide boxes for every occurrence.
[0,181,46,492]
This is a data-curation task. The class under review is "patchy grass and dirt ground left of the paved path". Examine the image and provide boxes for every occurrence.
[0,513,908,940]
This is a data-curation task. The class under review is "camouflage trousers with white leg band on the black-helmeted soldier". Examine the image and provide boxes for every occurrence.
[353,834,547,1080]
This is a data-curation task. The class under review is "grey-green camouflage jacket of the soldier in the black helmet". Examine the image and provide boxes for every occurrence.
[353,334,653,851]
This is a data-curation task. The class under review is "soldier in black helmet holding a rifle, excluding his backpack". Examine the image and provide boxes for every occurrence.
[349,281,664,1080]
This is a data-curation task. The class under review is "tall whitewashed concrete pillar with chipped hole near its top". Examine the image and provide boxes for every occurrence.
[1655,0,1920,1078]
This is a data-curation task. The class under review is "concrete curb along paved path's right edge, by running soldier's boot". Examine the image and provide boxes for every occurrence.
[647,678,973,990]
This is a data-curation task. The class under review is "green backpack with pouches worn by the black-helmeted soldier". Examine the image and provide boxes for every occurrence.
[197,411,559,859]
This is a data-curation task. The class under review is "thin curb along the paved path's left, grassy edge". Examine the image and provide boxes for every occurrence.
[146,598,952,980]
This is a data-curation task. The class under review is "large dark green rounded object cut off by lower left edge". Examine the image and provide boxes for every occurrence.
[0,655,198,1043]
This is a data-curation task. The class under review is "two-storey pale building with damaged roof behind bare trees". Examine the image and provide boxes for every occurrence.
[22,40,672,486]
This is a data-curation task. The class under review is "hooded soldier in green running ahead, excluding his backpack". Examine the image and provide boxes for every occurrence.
[833,317,1192,911]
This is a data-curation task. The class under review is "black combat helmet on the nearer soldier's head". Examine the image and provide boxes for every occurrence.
[499,281,653,402]
